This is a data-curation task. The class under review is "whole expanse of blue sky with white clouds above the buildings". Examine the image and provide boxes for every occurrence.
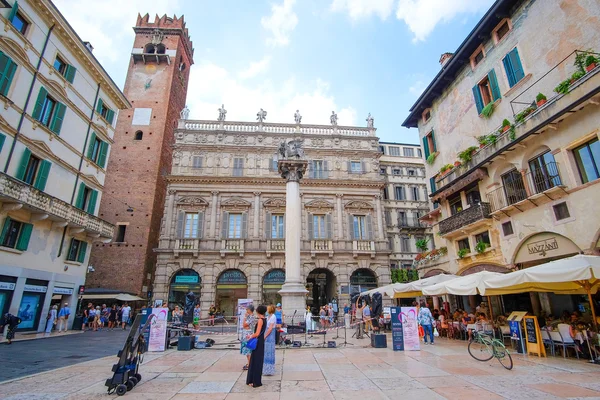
[55,0,493,143]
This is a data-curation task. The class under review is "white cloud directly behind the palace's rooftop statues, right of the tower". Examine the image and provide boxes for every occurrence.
[188,63,356,125]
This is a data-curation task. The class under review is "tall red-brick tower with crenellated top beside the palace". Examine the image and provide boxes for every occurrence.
[86,14,194,297]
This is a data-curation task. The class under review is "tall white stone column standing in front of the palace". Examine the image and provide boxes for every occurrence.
[278,154,308,316]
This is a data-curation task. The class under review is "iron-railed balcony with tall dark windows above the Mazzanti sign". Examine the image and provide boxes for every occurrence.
[487,162,566,215]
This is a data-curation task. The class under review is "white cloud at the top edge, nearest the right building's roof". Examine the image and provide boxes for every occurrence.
[396,0,493,42]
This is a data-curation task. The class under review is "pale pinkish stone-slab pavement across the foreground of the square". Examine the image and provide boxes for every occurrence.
[0,335,600,400]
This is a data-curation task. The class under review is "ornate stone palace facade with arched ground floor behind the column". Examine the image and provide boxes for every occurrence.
[153,115,432,315]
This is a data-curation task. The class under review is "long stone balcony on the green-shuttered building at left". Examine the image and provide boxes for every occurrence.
[0,173,115,238]
